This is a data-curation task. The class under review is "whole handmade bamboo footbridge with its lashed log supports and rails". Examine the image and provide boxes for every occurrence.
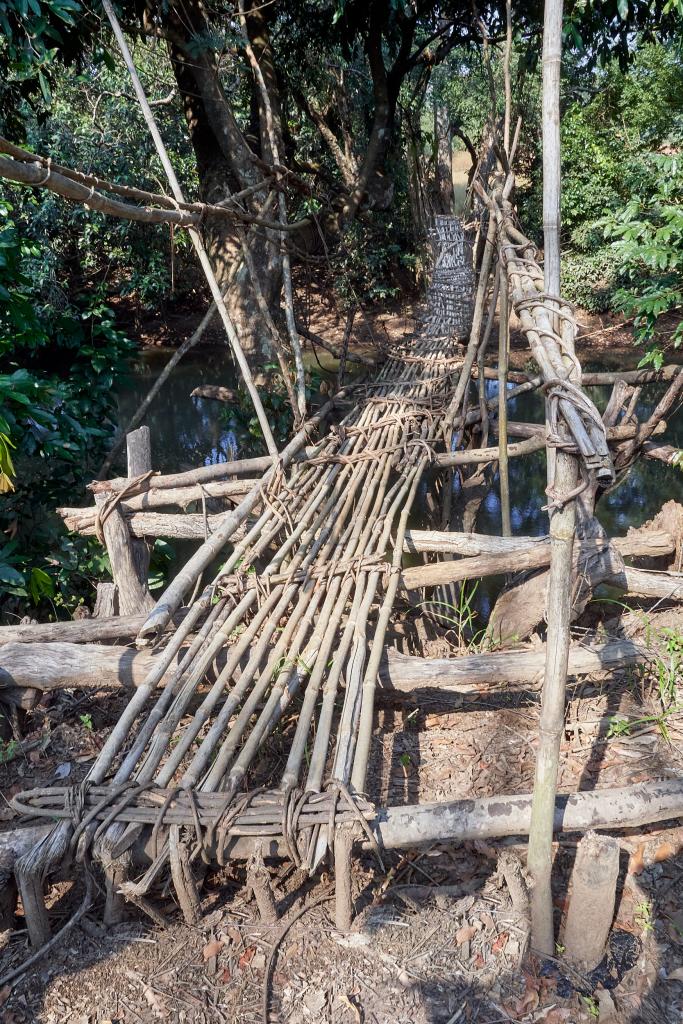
[0,70,683,974]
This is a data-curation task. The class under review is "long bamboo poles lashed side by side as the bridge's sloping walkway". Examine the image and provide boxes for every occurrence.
[12,288,471,939]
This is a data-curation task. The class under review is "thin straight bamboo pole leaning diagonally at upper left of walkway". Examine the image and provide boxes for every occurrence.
[102,0,278,457]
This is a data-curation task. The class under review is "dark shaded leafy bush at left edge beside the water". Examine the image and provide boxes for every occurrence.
[0,203,132,614]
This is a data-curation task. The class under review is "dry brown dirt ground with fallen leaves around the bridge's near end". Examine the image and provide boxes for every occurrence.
[0,307,683,1024]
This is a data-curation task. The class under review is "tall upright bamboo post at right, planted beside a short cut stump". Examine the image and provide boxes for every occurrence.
[527,0,579,954]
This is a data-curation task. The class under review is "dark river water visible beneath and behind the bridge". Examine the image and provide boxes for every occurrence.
[114,348,683,611]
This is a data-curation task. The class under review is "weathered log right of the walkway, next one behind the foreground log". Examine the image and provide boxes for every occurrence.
[380,640,648,693]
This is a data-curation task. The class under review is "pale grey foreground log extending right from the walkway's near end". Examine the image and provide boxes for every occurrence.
[374,779,683,849]
